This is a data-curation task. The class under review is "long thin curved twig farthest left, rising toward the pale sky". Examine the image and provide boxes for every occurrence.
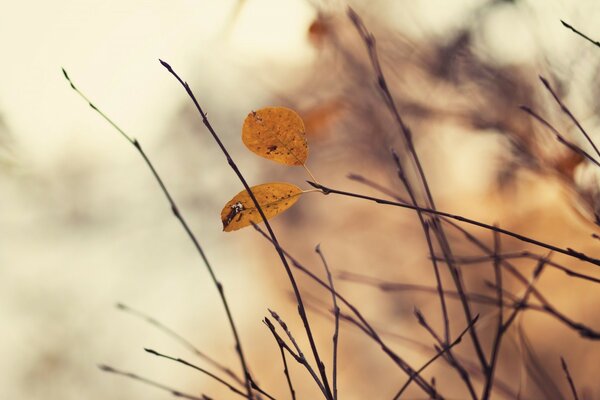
[62,69,253,399]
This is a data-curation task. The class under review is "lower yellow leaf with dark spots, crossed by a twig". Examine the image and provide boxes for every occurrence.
[221,182,303,232]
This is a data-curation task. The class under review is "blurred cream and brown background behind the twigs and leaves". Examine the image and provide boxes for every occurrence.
[0,0,600,400]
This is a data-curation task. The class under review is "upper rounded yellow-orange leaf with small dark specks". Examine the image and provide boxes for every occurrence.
[242,107,308,165]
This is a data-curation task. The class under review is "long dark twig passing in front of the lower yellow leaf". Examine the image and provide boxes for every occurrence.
[160,60,333,400]
